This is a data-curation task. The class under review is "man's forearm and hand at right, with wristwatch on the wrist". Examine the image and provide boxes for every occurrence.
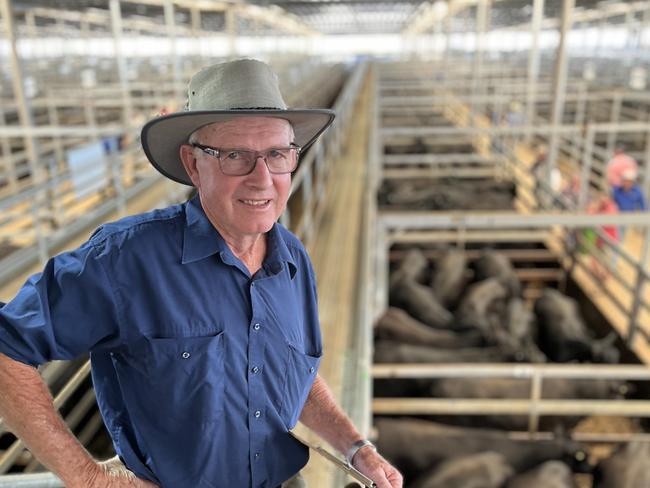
[300,375,402,488]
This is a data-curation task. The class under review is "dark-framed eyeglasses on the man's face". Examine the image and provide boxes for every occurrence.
[192,143,302,176]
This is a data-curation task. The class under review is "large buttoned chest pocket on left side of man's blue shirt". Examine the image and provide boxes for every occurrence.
[111,332,225,423]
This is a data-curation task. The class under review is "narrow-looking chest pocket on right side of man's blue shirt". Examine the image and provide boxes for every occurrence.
[280,344,321,429]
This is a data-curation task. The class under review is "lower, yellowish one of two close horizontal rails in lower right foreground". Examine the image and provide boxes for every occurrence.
[372,398,650,417]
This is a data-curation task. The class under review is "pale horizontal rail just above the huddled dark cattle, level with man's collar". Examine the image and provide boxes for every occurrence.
[379,211,650,230]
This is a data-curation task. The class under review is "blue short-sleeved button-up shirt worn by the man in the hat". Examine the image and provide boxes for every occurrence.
[0,199,322,488]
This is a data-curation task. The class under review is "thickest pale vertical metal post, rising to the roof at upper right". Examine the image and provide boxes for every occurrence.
[544,0,575,193]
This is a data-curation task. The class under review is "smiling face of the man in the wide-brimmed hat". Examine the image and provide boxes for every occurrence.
[181,117,297,239]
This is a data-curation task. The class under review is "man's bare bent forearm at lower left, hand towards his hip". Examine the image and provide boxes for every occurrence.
[0,353,155,488]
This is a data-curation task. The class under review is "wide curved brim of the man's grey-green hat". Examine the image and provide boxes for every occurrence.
[140,109,335,186]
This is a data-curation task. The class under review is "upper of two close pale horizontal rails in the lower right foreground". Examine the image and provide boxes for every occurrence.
[372,363,650,381]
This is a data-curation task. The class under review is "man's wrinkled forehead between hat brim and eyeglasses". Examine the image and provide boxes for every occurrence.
[198,117,294,146]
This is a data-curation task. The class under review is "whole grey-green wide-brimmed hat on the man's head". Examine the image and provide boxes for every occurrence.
[141,59,334,186]
